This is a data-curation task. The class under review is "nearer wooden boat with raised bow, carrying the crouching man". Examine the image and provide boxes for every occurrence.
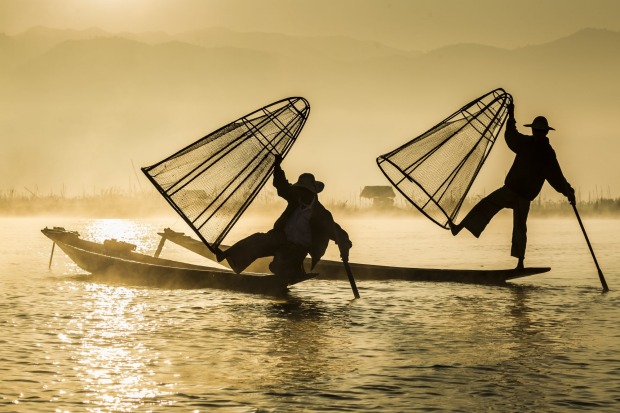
[41,227,317,295]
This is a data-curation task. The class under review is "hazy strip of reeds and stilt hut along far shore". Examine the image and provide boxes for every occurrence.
[0,189,620,218]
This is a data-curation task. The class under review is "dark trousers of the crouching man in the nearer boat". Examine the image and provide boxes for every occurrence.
[226,229,308,276]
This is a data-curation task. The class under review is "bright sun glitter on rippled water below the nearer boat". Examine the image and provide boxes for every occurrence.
[73,284,170,411]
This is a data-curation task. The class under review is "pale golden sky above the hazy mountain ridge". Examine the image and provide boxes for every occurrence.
[0,0,620,50]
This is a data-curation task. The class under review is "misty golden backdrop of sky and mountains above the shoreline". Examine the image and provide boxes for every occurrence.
[0,0,620,204]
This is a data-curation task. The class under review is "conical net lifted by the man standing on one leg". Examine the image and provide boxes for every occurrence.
[377,89,512,229]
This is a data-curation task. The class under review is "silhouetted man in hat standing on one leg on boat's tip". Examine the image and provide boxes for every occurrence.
[449,103,575,269]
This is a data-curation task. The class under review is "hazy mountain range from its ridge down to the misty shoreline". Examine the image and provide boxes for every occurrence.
[0,27,620,198]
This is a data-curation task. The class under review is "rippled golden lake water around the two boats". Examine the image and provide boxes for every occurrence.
[0,215,620,412]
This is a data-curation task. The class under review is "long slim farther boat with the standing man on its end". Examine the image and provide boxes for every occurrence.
[156,228,551,285]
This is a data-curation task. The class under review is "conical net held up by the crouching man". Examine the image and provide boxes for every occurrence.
[142,97,310,250]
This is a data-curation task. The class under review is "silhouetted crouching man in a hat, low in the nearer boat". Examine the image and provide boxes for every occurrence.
[217,156,353,278]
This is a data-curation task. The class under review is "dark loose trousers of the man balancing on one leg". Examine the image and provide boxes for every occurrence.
[461,186,531,259]
